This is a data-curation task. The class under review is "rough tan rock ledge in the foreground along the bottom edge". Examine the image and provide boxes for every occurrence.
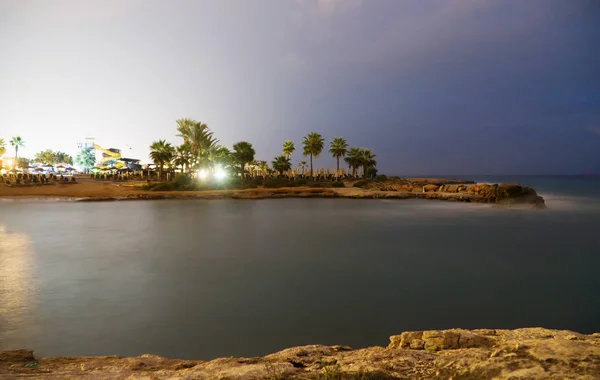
[0,328,600,379]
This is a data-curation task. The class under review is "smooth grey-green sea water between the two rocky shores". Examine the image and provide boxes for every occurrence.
[0,177,600,359]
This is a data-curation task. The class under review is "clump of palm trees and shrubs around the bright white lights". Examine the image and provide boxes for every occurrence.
[135,118,376,190]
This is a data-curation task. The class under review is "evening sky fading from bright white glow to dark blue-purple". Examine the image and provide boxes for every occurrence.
[0,0,600,175]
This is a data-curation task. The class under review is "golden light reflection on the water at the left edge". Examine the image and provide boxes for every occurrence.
[0,225,35,342]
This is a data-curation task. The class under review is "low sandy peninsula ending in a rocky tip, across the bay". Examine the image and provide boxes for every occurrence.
[0,176,545,208]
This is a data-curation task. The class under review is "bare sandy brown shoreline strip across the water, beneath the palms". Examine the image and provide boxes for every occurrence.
[0,179,545,208]
